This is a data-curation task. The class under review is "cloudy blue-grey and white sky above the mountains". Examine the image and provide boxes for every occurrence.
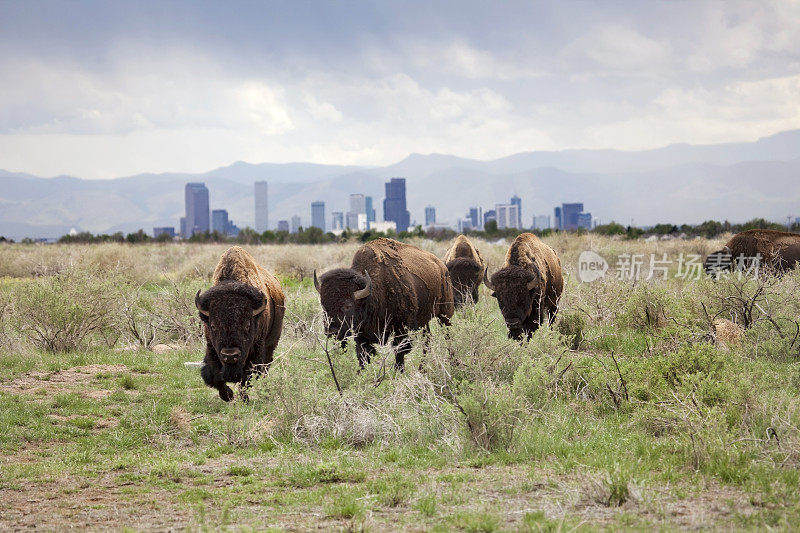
[0,0,800,178]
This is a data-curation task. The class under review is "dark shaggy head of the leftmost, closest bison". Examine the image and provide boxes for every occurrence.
[194,281,267,382]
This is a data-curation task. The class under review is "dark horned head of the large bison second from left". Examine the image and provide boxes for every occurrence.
[314,268,372,340]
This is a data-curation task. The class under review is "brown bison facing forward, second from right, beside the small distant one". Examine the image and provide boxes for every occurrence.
[485,233,564,339]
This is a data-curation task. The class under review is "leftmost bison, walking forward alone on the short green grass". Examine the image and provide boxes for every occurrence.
[195,246,285,402]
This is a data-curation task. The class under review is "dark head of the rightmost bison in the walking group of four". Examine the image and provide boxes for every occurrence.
[484,266,542,339]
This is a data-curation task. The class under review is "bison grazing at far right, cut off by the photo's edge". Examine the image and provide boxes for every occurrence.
[704,229,800,276]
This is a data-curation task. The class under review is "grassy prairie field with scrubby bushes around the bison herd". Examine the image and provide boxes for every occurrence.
[0,234,800,531]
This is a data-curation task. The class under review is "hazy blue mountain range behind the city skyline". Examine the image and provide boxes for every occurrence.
[0,130,800,239]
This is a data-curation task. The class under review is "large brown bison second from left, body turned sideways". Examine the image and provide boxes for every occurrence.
[314,239,453,370]
